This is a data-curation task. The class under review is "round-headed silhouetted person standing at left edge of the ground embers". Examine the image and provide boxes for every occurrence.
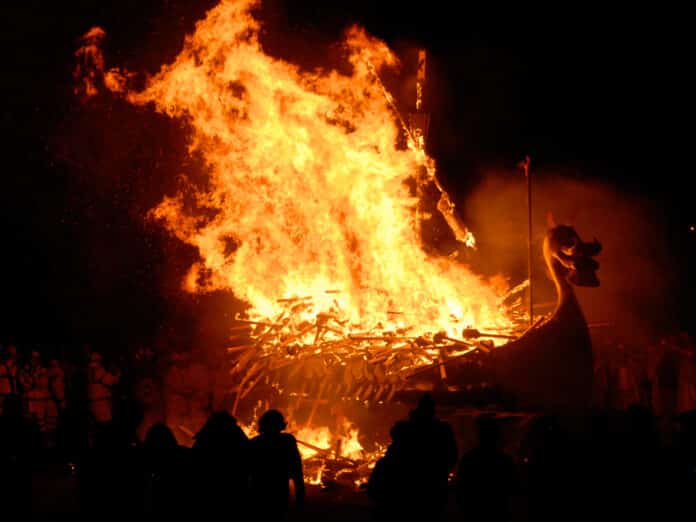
[250,410,305,520]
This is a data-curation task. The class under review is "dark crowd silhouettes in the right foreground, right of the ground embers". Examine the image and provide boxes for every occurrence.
[368,395,696,522]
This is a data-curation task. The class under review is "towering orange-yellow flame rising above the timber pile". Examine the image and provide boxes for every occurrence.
[84,0,507,333]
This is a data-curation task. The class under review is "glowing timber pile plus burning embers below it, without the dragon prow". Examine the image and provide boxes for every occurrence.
[227,297,524,482]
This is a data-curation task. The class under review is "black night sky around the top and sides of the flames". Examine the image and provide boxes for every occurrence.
[0,0,696,345]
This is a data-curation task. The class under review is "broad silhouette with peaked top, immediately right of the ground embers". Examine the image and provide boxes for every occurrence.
[368,394,457,520]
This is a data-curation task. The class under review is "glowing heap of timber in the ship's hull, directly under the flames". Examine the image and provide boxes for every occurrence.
[227,299,513,414]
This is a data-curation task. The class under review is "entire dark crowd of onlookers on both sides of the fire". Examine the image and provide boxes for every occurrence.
[0,340,696,522]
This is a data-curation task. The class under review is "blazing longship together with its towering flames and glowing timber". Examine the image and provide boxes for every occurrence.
[78,0,596,482]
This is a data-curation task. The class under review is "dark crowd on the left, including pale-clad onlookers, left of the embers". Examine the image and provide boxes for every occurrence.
[0,345,304,520]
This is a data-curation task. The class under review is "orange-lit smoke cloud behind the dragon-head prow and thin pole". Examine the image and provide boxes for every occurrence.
[466,170,678,341]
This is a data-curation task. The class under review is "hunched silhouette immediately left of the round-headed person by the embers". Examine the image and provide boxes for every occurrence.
[192,411,249,513]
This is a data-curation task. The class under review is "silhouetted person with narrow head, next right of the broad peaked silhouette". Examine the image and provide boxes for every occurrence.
[456,416,518,522]
